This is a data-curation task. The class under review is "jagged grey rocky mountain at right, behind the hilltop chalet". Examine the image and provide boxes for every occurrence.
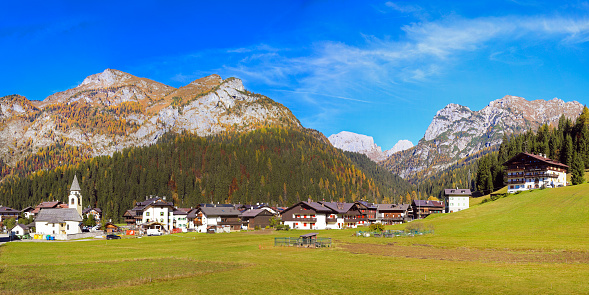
[381,95,583,180]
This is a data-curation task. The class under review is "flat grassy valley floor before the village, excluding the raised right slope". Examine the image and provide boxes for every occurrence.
[0,230,589,294]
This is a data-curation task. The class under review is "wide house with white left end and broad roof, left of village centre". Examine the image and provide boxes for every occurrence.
[192,206,243,233]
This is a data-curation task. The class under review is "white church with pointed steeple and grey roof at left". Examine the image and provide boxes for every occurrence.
[35,175,82,239]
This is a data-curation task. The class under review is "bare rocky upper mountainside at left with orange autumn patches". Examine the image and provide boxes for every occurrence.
[0,69,302,164]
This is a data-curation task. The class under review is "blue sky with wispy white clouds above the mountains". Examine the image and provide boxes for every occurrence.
[0,0,589,149]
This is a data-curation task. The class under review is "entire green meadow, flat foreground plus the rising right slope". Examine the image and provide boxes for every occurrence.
[0,184,589,294]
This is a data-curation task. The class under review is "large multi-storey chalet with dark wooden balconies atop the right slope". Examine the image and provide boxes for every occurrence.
[503,153,569,193]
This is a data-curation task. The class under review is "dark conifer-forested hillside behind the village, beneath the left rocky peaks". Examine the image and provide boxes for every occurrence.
[0,128,412,221]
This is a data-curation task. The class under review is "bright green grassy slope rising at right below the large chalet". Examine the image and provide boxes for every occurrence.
[396,184,589,251]
